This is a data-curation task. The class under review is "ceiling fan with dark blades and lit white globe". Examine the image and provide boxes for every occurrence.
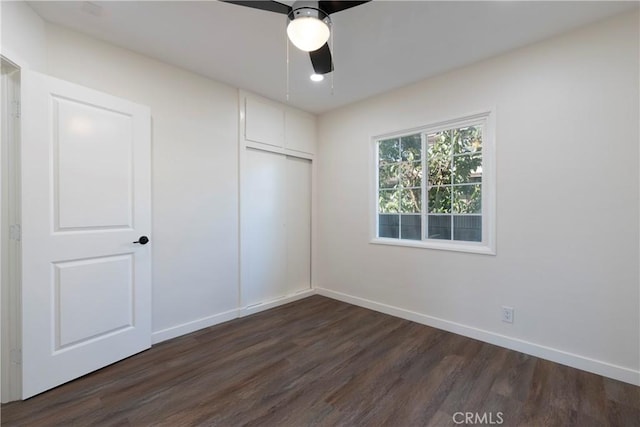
[222,0,371,75]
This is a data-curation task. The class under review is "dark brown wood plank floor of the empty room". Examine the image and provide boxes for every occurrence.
[2,296,640,427]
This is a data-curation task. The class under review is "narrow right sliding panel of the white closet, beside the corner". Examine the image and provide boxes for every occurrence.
[284,157,311,294]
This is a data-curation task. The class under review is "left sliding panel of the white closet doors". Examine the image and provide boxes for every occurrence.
[240,148,287,306]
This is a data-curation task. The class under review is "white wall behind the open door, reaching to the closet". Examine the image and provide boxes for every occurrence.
[46,24,238,341]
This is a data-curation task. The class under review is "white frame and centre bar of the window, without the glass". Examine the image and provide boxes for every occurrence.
[369,109,496,255]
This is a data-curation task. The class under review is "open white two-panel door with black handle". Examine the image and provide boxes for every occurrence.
[21,72,151,398]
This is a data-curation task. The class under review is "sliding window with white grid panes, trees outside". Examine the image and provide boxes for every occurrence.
[373,113,495,253]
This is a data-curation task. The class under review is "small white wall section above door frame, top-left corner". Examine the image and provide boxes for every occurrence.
[0,1,45,71]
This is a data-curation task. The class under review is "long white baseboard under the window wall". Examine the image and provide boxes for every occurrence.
[315,288,640,385]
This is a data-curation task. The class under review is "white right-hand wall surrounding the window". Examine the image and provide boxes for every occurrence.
[314,14,640,383]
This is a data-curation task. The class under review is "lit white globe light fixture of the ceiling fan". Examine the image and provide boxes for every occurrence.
[287,7,331,52]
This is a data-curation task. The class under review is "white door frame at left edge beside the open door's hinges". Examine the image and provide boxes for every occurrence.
[0,55,22,403]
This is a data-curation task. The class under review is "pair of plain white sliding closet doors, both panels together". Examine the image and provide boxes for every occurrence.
[240,148,311,307]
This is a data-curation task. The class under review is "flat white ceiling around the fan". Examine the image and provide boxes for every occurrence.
[29,0,638,113]
